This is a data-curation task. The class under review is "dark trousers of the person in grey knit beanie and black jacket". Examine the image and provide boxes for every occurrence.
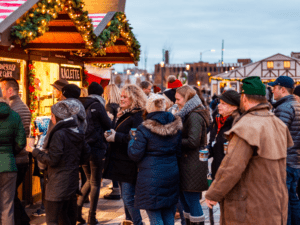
[46,195,77,225]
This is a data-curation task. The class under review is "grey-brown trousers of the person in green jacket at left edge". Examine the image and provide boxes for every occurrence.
[0,172,17,225]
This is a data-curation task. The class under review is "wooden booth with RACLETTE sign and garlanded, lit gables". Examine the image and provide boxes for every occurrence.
[0,0,140,204]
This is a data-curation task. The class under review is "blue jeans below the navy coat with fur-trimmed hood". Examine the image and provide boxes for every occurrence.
[146,205,176,225]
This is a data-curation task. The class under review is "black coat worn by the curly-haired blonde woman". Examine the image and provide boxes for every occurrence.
[103,109,143,184]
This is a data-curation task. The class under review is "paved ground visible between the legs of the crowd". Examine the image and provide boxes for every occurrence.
[26,179,220,225]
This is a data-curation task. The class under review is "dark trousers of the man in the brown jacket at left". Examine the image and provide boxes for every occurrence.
[14,163,30,225]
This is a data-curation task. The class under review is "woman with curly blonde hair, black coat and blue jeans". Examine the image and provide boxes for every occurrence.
[103,84,147,225]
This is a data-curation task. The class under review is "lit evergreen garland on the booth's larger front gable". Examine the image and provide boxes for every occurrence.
[11,0,105,55]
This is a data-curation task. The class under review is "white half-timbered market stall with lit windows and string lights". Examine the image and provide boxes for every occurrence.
[210,53,300,95]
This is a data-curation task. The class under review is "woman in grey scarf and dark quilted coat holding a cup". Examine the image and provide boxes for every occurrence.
[175,85,209,225]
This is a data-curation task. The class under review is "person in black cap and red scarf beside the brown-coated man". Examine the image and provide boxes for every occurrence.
[207,90,240,179]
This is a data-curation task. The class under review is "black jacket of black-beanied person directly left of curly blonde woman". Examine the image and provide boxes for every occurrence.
[79,97,112,158]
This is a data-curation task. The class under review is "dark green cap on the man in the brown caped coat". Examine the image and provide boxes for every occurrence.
[241,76,266,96]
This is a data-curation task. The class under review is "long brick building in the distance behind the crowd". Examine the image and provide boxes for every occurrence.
[154,59,252,87]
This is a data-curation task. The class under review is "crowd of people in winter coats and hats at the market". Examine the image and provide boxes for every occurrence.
[0,76,300,225]
